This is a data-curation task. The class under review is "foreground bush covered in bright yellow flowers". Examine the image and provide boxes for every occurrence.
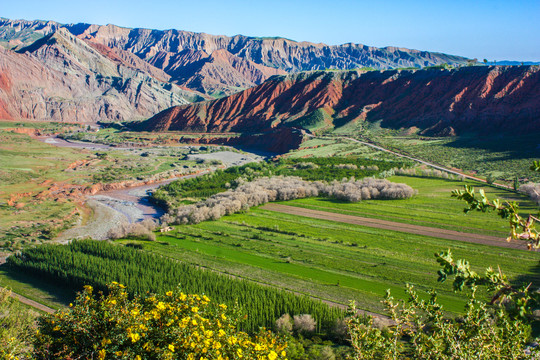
[34,282,287,360]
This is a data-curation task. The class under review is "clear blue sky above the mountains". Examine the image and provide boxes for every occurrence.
[0,0,540,61]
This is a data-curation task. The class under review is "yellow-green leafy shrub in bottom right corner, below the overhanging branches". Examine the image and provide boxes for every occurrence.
[348,286,531,360]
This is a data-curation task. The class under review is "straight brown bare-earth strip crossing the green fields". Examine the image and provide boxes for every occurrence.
[261,204,527,250]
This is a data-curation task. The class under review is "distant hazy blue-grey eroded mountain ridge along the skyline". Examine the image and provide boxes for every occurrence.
[0,19,467,95]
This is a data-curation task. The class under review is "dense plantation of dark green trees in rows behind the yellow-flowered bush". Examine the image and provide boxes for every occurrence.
[8,240,342,331]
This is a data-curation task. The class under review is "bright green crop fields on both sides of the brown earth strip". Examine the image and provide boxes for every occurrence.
[118,177,540,318]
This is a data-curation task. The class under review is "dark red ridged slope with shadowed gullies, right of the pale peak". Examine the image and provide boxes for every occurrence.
[139,66,540,135]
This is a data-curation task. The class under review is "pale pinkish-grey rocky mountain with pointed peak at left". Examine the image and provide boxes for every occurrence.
[0,28,201,123]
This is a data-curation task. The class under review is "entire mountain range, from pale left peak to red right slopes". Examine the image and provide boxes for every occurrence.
[0,19,540,151]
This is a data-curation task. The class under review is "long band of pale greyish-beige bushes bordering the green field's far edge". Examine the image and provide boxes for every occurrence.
[162,176,415,224]
